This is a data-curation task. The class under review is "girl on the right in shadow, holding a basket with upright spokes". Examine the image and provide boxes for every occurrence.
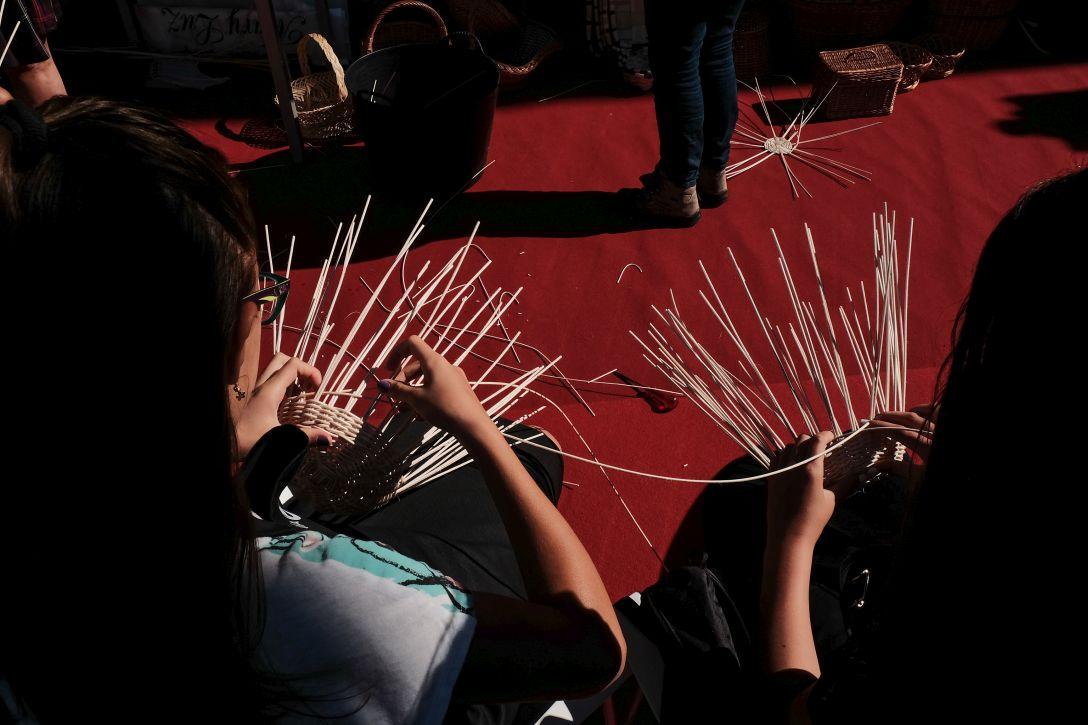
[762,170,1088,724]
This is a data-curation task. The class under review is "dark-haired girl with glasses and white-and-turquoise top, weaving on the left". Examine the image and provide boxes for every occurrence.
[0,98,625,723]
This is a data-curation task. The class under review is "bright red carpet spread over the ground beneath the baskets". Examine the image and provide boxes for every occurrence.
[184,65,1088,598]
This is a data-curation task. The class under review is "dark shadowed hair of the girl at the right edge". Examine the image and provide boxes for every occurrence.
[874,170,1088,722]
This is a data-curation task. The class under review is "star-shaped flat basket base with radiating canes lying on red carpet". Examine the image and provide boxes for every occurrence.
[726,79,880,199]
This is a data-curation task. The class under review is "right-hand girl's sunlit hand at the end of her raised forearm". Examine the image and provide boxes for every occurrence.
[767,431,834,546]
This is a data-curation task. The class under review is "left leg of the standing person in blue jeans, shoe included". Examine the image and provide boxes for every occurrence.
[635,0,706,225]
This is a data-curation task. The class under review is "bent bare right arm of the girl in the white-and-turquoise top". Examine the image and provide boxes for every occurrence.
[383,336,626,701]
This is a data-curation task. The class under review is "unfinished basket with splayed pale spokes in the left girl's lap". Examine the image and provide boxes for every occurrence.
[265,199,559,513]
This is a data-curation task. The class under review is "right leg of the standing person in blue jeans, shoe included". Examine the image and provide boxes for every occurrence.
[698,0,744,208]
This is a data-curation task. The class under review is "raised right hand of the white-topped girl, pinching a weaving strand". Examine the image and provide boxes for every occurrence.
[378,335,497,439]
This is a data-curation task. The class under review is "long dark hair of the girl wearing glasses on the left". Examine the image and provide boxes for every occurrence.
[0,98,261,722]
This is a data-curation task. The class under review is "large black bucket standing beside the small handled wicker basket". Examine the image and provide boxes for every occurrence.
[346,38,498,195]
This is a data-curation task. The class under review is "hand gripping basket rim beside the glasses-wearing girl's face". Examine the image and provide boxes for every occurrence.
[234,353,333,458]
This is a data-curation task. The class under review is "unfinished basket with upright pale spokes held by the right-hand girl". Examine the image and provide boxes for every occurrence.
[631,207,914,480]
